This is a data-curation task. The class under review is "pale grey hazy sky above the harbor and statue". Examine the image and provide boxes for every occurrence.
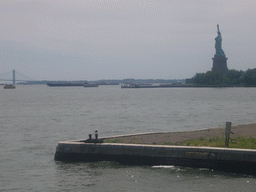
[0,0,256,80]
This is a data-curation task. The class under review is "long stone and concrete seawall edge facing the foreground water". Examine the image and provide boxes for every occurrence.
[54,140,256,174]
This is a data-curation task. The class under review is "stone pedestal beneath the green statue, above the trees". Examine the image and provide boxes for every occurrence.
[212,54,228,74]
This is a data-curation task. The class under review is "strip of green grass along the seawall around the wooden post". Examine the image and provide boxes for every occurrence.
[183,137,256,149]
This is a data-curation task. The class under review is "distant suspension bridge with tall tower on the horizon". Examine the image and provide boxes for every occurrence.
[0,70,35,84]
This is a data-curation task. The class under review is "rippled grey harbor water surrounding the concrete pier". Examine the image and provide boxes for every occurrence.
[0,85,256,191]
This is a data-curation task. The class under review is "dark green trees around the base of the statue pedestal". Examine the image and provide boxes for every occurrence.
[192,68,256,86]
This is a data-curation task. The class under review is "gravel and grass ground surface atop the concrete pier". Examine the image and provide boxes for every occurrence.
[104,123,256,149]
